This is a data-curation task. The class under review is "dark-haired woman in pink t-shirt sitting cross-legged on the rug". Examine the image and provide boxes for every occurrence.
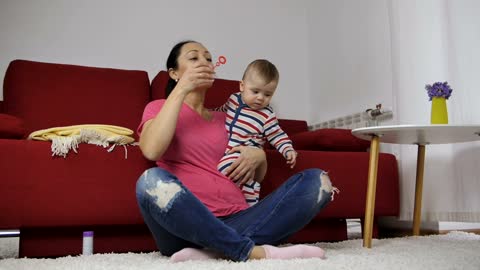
[136,41,332,261]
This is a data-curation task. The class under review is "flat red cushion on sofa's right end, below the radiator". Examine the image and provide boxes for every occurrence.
[290,128,370,152]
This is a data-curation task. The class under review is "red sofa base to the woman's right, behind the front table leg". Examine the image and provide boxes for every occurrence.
[260,150,400,220]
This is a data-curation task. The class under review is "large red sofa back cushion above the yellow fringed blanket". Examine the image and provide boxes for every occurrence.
[3,60,150,137]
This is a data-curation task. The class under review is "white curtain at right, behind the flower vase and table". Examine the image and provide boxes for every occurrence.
[387,0,480,222]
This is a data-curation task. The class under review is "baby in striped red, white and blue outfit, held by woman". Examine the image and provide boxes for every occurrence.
[217,59,297,206]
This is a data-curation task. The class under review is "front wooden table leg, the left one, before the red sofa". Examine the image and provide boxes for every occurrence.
[363,135,380,248]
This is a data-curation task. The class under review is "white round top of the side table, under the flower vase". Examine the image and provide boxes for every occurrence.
[352,125,480,145]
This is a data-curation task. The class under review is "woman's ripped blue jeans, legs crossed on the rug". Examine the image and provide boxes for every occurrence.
[136,167,333,261]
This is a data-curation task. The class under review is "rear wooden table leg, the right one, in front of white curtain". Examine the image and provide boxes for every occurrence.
[413,145,425,235]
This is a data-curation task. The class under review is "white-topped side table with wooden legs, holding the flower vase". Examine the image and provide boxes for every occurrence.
[352,125,480,248]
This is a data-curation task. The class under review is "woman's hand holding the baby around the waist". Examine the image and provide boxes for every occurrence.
[226,146,267,184]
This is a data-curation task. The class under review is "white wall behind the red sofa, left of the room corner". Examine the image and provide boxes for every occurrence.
[0,0,310,120]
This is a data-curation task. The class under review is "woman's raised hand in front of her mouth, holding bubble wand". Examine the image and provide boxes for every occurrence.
[175,62,215,94]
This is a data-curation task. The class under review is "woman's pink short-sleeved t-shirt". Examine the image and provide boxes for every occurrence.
[137,99,248,216]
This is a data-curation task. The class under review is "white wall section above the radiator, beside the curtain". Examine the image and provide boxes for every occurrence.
[307,0,393,123]
